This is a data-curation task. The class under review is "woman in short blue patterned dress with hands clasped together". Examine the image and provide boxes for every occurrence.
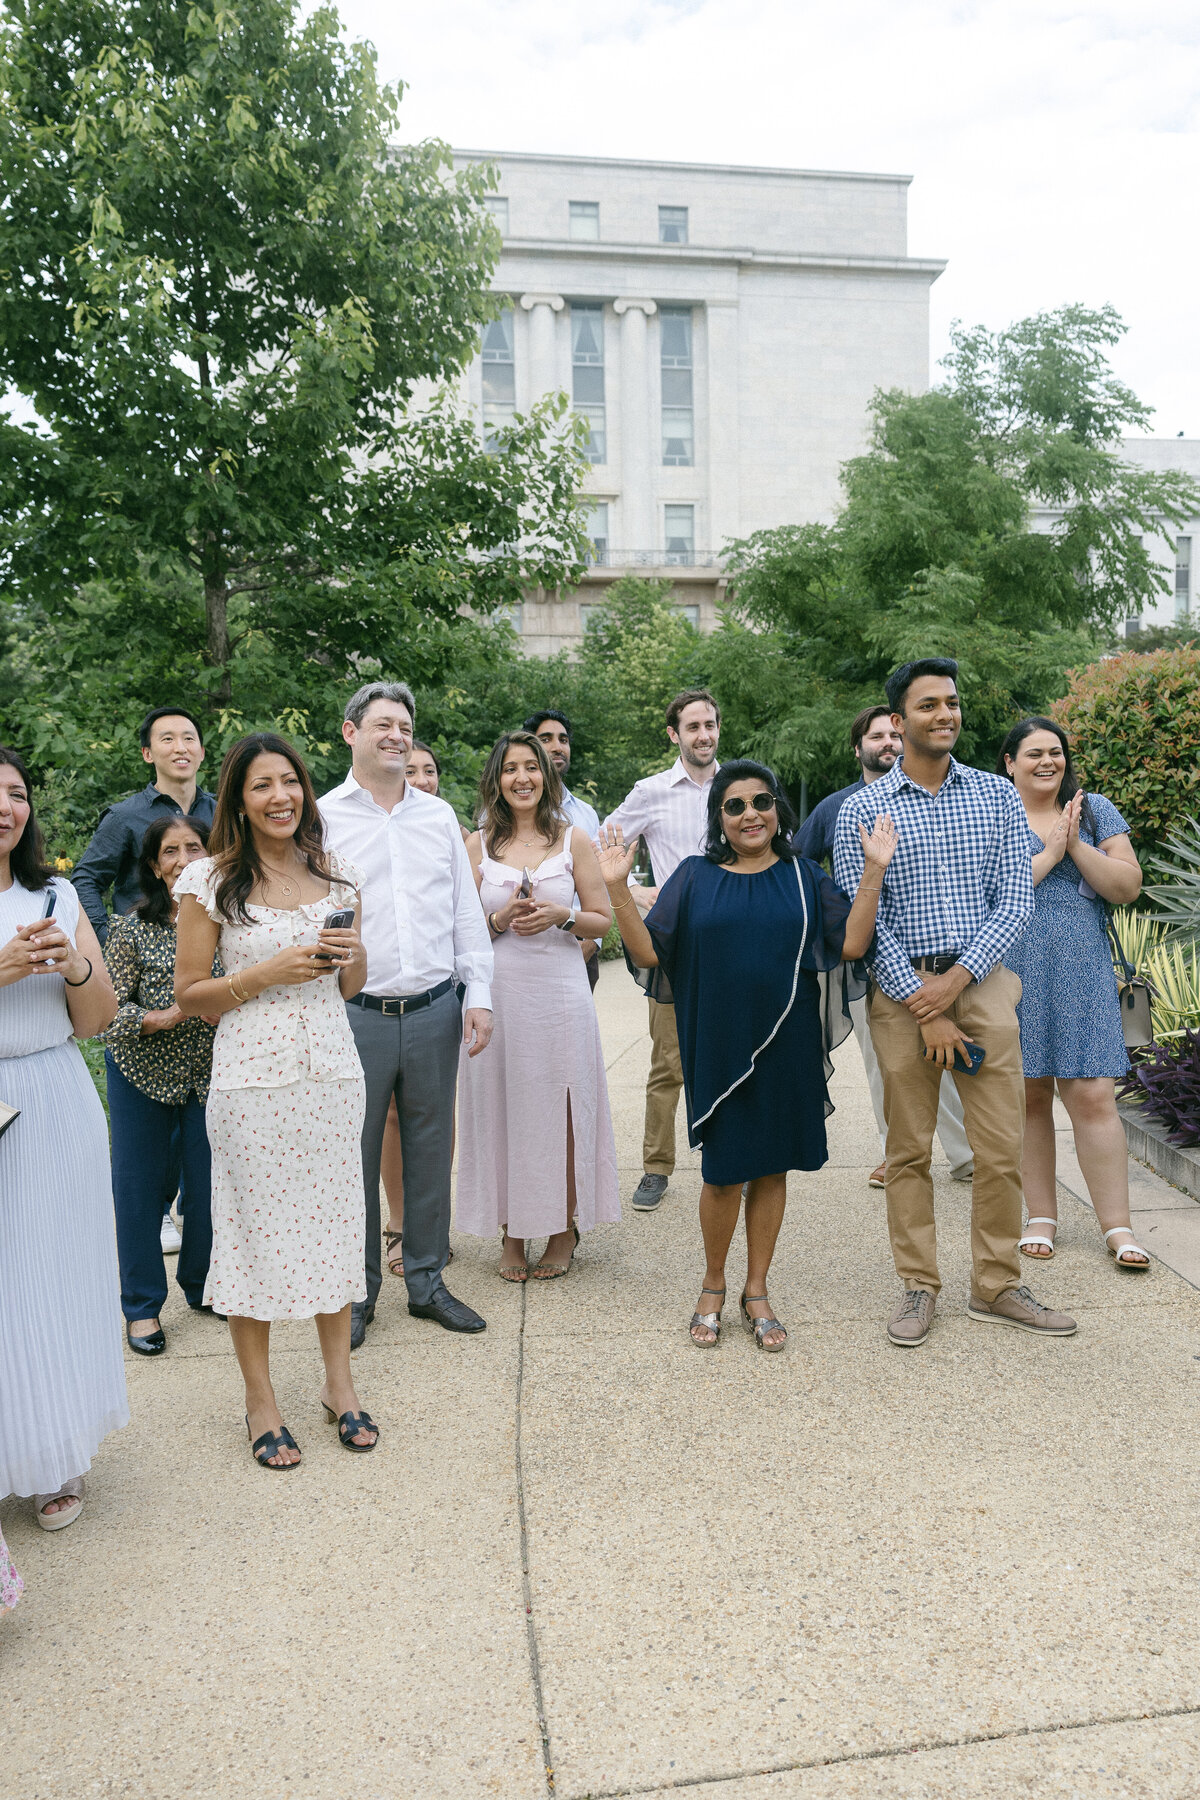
[997,718,1150,1271]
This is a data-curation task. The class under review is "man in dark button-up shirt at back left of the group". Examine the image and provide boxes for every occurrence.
[70,706,216,943]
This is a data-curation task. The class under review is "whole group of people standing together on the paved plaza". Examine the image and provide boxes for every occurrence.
[0,659,1148,1604]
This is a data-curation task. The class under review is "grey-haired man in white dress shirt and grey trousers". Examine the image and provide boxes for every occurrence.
[320,682,493,1348]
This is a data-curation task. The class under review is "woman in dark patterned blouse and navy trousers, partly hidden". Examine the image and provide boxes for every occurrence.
[104,814,219,1355]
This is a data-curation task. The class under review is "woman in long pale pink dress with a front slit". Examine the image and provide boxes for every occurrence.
[455,731,621,1282]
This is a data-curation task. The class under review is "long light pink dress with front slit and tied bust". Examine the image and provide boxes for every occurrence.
[455,830,621,1237]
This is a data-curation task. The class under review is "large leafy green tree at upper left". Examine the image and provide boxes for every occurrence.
[0,0,581,736]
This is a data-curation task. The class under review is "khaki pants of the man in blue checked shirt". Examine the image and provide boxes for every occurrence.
[867,965,1025,1301]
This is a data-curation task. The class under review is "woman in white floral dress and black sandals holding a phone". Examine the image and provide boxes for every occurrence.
[175,733,380,1469]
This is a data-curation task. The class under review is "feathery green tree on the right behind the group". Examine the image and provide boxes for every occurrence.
[705,306,1200,797]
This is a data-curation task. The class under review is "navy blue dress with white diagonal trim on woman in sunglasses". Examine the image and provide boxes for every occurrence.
[646,857,855,1186]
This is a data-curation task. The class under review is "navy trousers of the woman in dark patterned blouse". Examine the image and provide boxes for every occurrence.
[104,1051,212,1319]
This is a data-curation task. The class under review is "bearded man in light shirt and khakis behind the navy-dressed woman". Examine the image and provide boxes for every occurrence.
[604,688,721,1213]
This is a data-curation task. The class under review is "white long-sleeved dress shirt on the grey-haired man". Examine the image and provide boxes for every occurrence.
[317,774,493,1008]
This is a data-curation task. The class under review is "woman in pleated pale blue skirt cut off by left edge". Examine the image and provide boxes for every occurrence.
[0,747,130,1532]
